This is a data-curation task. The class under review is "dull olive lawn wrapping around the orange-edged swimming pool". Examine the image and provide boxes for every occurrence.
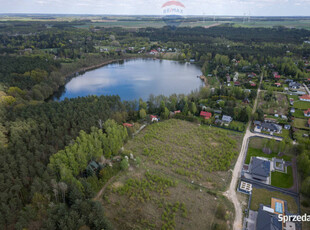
[250,188,298,213]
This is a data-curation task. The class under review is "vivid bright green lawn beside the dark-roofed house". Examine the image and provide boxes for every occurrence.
[271,166,294,188]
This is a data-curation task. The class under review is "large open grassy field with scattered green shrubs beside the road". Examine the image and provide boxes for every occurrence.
[102,120,242,229]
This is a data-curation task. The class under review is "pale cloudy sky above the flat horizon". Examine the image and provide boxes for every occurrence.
[0,0,310,16]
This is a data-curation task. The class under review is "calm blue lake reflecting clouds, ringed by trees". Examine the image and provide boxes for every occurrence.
[53,59,203,101]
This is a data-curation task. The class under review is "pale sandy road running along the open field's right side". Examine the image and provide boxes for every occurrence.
[224,75,282,230]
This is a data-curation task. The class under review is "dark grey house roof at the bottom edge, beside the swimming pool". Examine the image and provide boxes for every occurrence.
[256,205,282,230]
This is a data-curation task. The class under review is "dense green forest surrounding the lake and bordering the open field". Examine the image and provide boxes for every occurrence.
[0,21,310,229]
